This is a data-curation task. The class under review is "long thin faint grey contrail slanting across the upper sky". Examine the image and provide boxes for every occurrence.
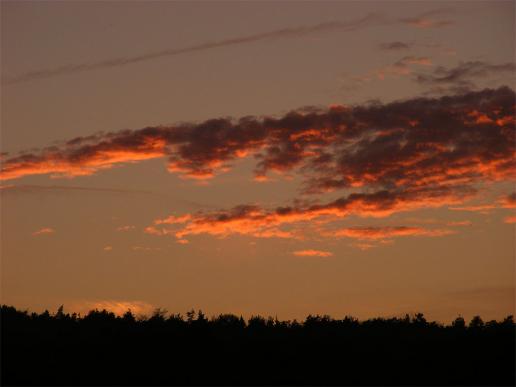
[2,13,385,85]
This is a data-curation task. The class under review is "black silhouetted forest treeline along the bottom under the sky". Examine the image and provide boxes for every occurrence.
[1,305,516,386]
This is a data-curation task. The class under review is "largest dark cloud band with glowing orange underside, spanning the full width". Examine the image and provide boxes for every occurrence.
[4,88,515,196]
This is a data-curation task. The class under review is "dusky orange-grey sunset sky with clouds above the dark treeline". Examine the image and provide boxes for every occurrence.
[0,1,516,322]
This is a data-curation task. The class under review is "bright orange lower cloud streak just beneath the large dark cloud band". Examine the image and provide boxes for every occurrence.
[145,187,474,239]
